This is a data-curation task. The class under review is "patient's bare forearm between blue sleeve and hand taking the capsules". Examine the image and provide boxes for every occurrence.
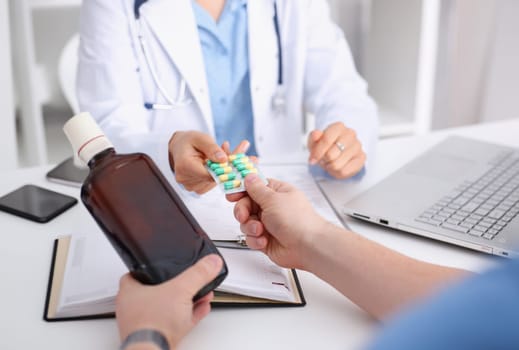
[305,224,468,319]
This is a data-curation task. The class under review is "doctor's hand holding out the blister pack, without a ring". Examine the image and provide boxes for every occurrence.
[169,131,227,194]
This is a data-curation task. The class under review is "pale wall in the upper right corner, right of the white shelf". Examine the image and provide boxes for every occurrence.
[433,0,519,128]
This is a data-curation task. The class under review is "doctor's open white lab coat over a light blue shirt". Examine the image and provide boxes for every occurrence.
[77,0,378,177]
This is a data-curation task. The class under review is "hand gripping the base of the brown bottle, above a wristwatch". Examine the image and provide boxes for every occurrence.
[116,254,222,349]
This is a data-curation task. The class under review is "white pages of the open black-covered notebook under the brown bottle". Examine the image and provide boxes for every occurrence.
[57,231,296,318]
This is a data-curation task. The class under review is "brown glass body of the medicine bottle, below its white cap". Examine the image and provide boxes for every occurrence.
[63,113,227,299]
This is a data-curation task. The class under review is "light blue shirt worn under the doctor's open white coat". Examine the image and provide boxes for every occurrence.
[192,0,257,155]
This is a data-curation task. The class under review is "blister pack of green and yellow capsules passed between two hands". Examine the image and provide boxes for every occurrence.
[205,153,268,194]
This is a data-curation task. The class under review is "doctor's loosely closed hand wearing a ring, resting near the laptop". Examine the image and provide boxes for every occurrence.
[308,122,366,179]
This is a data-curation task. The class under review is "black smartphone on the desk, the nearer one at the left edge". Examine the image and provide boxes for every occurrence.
[0,185,77,223]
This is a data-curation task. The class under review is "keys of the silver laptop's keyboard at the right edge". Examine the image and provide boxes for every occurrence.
[416,152,519,240]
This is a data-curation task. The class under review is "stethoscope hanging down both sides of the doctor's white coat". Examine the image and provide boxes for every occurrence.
[133,0,286,115]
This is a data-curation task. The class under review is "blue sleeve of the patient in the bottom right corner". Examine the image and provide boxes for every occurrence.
[370,260,519,350]
